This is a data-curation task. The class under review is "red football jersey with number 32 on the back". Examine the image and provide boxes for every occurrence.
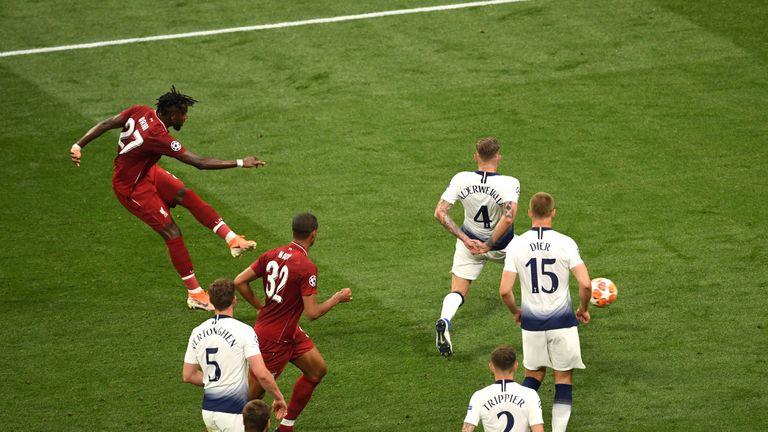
[251,242,317,342]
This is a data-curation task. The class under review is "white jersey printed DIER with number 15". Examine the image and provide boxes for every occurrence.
[504,227,583,331]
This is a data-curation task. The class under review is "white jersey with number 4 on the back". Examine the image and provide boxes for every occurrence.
[440,171,520,250]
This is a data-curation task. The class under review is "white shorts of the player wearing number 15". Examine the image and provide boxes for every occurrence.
[523,326,586,371]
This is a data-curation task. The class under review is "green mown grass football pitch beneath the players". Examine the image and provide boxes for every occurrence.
[0,0,768,432]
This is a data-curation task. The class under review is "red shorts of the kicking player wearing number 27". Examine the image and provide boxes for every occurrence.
[115,165,185,232]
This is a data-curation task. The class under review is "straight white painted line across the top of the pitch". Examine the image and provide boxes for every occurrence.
[0,0,528,57]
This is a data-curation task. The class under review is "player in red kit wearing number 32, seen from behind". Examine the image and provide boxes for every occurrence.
[235,213,352,432]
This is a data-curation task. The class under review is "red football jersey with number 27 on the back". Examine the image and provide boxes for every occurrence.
[112,105,187,195]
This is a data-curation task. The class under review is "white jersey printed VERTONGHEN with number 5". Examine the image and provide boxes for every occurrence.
[184,315,261,414]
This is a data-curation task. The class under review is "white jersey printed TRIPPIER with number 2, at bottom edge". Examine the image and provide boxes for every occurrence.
[464,380,544,432]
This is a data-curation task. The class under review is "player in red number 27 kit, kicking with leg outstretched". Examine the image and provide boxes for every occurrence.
[70,87,266,310]
